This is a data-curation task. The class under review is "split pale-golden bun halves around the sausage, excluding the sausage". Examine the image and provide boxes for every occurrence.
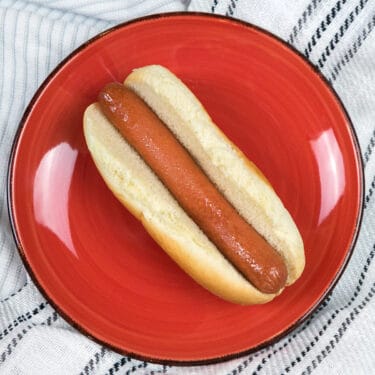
[84,66,305,304]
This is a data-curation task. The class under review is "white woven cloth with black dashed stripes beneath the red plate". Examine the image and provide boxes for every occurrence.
[0,0,375,375]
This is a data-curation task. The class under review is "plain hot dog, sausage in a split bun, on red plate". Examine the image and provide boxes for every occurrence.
[84,66,305,304]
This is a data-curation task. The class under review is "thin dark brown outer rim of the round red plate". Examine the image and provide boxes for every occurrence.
[6,11,365,366]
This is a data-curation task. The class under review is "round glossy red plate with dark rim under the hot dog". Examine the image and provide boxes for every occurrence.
[9,13,363,363]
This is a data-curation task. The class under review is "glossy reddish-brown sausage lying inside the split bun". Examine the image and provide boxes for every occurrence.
[98,83,287,293]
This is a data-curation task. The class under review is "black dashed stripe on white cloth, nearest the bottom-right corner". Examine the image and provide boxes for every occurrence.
[302,283,375,375]
